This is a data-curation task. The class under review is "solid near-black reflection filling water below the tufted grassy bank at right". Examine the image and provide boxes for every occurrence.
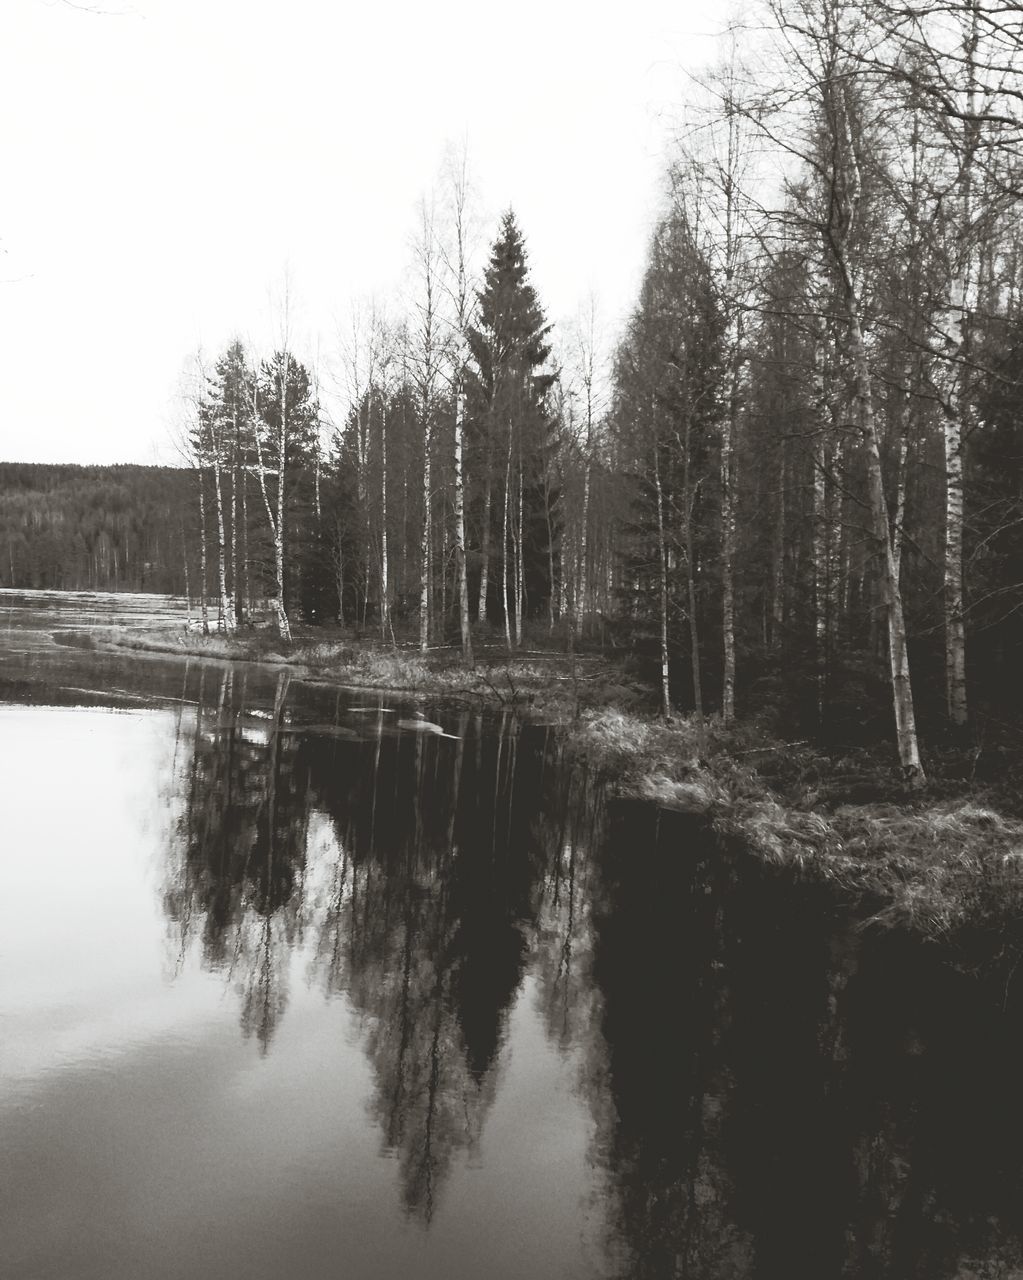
[589,812,1023,1280]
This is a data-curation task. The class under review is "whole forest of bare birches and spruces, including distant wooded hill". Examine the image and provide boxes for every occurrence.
[0,0,1023,782]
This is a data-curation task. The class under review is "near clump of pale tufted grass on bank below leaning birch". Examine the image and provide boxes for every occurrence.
[568,710,1023,938]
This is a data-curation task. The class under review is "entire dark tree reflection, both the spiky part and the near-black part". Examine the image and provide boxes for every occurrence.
[166,672,1023,1280]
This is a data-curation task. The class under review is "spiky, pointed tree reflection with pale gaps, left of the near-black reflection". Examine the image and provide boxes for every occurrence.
[165,671,581,1221]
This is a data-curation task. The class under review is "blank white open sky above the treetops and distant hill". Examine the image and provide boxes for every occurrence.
[0,0,722,465]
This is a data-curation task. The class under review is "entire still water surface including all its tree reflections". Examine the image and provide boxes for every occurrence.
[0,599,1023,1280]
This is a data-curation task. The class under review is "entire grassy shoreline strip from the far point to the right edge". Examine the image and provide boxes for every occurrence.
[96,627,1023,937]
